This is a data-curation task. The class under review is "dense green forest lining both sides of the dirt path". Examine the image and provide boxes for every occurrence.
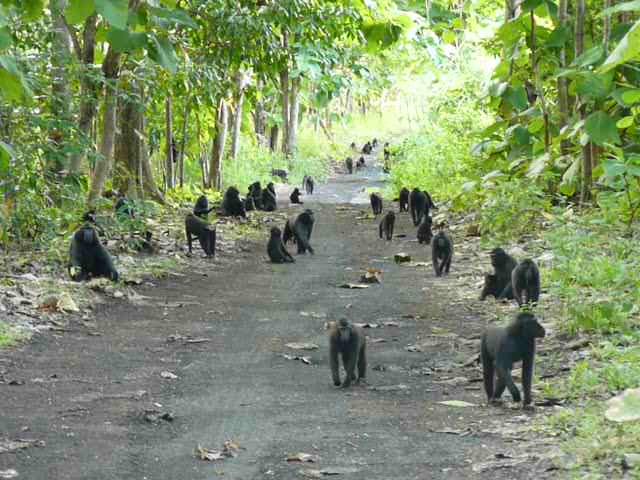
[0,0,640,478]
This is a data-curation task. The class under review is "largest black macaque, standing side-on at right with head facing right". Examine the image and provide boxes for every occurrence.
[480,312,546,408]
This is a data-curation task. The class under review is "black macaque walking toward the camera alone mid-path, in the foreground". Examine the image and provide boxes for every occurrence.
[329,318,367,388]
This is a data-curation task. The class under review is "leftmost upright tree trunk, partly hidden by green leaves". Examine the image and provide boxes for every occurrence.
[47,0,71,173]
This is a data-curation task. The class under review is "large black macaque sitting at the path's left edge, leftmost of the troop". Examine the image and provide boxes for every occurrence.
[67,225,120,282]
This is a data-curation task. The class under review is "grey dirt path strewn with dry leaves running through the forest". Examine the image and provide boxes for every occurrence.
[0,157,543,480]
